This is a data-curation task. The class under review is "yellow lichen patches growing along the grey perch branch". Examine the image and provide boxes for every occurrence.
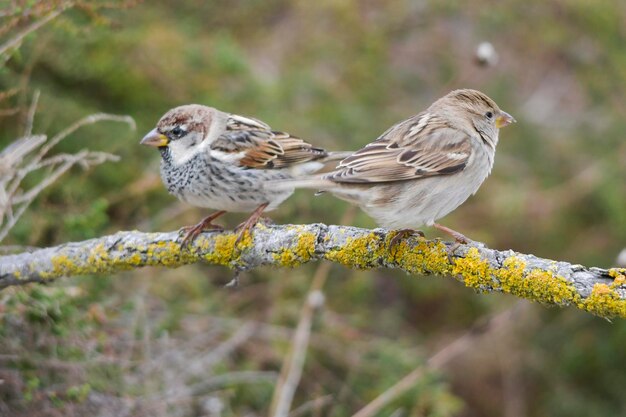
[24,229,626,318]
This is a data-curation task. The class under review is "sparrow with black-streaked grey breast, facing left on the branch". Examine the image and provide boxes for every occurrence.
[140,104,350,245]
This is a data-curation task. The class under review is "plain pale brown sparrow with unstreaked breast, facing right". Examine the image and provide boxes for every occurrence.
[268,89,515,242]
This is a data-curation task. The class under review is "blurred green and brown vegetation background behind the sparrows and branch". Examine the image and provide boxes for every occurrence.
[0,0,626,417]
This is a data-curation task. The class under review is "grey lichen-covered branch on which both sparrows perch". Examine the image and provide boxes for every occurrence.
[0,224,626,318]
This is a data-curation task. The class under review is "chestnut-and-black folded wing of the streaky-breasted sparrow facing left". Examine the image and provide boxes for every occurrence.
[210,114,327,169]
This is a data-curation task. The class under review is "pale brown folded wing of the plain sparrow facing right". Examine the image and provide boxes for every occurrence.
[324,113,472,183]
